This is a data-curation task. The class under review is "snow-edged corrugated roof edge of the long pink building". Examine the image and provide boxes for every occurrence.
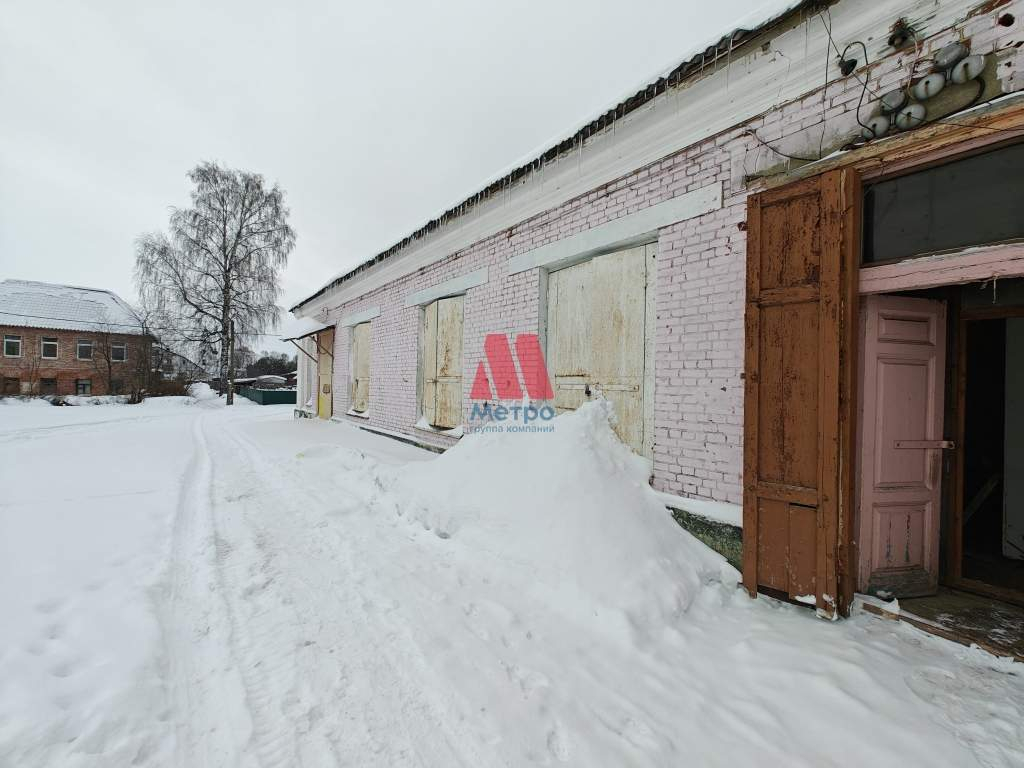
[290,0,815,311]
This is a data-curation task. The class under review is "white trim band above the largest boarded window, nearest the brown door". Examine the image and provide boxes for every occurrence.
[508,181,722,274]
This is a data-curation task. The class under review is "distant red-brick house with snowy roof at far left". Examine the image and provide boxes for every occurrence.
[0,280,150,395]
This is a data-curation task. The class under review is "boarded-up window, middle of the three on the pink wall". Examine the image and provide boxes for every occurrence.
[420,296,464,429]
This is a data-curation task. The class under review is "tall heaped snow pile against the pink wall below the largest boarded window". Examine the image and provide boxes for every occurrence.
[393,400,738,634]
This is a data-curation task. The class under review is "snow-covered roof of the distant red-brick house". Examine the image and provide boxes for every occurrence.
[0,280,142,334]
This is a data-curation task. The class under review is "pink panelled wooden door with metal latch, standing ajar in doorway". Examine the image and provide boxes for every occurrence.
[858,296,948,597]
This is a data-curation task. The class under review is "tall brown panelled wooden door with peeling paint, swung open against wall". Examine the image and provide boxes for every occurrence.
[743,171,855,616]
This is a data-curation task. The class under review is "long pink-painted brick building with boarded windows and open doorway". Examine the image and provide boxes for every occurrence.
[292,0,1024,630]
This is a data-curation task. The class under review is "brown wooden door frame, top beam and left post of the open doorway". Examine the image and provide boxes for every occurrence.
[757,95,1024,614]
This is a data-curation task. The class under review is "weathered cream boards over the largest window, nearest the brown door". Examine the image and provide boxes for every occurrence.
[547,244,655,456]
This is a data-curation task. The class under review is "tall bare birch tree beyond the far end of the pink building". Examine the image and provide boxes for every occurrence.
[135,163,295,404]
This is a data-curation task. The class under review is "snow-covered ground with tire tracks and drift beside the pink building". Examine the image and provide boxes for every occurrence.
[0,398,1024,768]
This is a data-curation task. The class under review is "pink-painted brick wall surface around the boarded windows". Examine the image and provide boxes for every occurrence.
[311,7,1022,504]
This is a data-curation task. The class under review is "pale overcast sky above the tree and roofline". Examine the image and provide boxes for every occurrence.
[0,0,779,352]
